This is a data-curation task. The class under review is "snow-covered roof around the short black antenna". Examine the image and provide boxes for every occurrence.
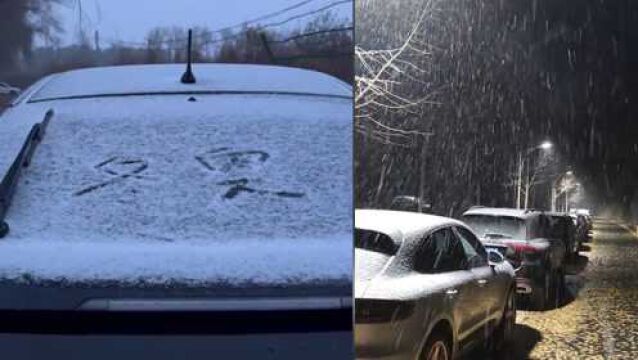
[27,64,352,102]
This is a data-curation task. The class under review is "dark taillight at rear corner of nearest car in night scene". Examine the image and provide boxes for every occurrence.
[354,299,414,324]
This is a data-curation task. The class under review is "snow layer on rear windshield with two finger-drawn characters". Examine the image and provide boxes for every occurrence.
[0,91,352,283]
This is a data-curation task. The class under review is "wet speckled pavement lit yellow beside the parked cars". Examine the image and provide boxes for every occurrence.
[478,220,638,360]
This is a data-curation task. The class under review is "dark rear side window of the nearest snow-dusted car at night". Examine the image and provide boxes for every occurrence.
[414,228,467,273]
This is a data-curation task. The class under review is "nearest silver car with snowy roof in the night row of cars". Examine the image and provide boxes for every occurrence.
[355,210,516,359]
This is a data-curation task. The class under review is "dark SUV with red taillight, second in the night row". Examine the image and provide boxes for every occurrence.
[462,207,566,309]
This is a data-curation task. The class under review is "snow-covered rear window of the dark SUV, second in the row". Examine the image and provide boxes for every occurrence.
[463,215,527,240]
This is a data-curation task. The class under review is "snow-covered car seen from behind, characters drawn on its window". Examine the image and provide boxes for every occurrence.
[0,64,352,346]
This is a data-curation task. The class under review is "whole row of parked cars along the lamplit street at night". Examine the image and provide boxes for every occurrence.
[355,206,592,359]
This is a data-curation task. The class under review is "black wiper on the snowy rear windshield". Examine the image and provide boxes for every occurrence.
[0,110,53,238]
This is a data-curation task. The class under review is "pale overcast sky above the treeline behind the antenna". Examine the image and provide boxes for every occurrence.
[53,0,352,46]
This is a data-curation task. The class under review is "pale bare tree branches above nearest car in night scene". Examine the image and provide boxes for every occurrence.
[354,0,434,211]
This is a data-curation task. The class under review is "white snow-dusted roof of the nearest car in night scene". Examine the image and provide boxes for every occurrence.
[354,209,466,241]
